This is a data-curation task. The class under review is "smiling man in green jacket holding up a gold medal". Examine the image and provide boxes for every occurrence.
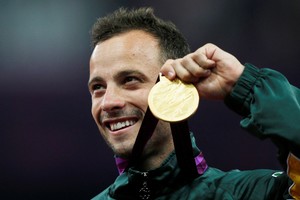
[89,8,300,200]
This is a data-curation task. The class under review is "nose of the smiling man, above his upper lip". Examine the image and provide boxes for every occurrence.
[101,88,125,112]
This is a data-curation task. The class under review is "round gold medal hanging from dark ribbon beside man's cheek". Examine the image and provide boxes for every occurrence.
[148,76,199,122]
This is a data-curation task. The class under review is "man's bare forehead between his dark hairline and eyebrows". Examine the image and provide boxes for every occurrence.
[90,30,162,71]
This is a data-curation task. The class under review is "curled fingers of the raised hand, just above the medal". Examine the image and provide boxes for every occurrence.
[161,51,215,82]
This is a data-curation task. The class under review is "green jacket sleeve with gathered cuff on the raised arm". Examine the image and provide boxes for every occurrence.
[225,63,300,197]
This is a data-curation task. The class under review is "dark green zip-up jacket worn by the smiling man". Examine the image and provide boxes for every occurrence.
[93,64,300,200]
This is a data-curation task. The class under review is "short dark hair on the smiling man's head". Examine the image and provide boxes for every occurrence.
[91,7,190,62]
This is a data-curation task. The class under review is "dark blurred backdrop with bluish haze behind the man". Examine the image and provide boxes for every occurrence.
[0,0,300,200]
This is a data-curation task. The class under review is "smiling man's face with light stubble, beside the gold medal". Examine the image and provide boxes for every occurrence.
[89,31,171,157]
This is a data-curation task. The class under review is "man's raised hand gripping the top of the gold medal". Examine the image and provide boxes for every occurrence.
[161,44,244,99]
